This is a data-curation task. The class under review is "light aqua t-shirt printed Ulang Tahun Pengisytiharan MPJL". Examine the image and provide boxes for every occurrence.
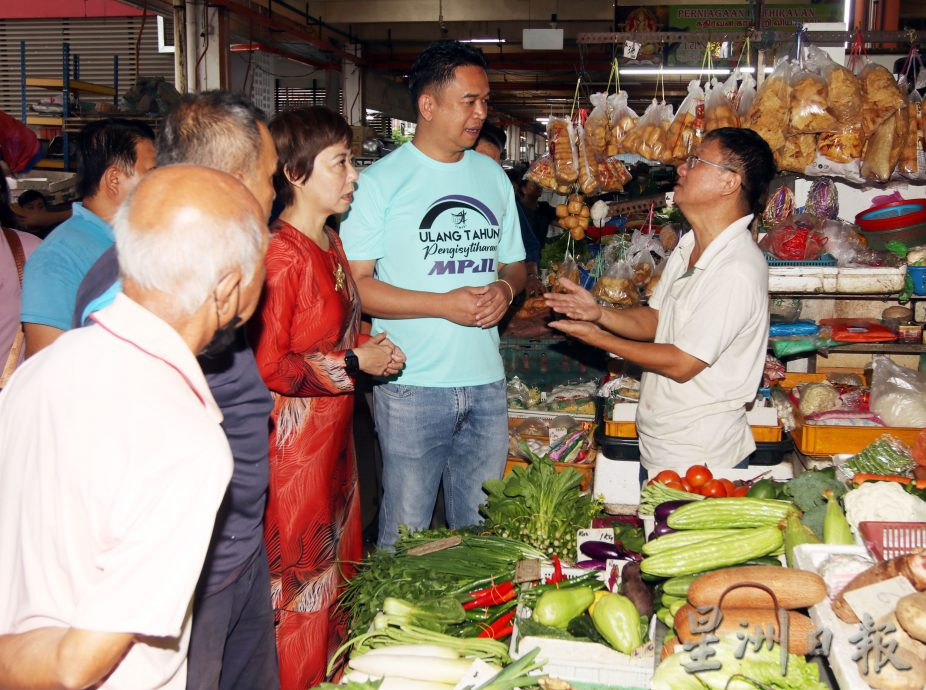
[341,143,524,388]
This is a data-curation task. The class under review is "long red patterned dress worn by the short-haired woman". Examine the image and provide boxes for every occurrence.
[255,221,362,690]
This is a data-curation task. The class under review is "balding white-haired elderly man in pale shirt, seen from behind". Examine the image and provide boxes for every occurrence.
[0,165,267,689]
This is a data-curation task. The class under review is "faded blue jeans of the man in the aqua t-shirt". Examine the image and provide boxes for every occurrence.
[373,379,508,549]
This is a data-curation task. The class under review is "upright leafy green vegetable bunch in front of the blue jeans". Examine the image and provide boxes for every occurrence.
[480,458,601,560]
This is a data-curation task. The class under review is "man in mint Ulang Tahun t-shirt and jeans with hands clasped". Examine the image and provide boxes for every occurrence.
[341,41,527,548]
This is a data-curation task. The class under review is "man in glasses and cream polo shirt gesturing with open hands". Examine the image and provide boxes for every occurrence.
[547,128,775,472]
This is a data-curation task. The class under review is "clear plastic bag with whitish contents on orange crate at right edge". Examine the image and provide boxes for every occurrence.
[870,357,926,427]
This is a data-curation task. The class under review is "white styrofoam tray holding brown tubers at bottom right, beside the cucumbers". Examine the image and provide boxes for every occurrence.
[794,544,874,690]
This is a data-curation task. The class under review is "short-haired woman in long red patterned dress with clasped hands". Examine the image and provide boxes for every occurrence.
[255,108,404,690]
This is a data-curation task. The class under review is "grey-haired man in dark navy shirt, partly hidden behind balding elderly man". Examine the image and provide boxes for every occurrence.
[74,91,279,690]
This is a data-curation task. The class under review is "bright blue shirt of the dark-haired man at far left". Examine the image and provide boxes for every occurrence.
[22,202,116,331]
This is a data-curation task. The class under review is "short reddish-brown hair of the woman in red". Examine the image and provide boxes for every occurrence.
[269,106,353,206]
